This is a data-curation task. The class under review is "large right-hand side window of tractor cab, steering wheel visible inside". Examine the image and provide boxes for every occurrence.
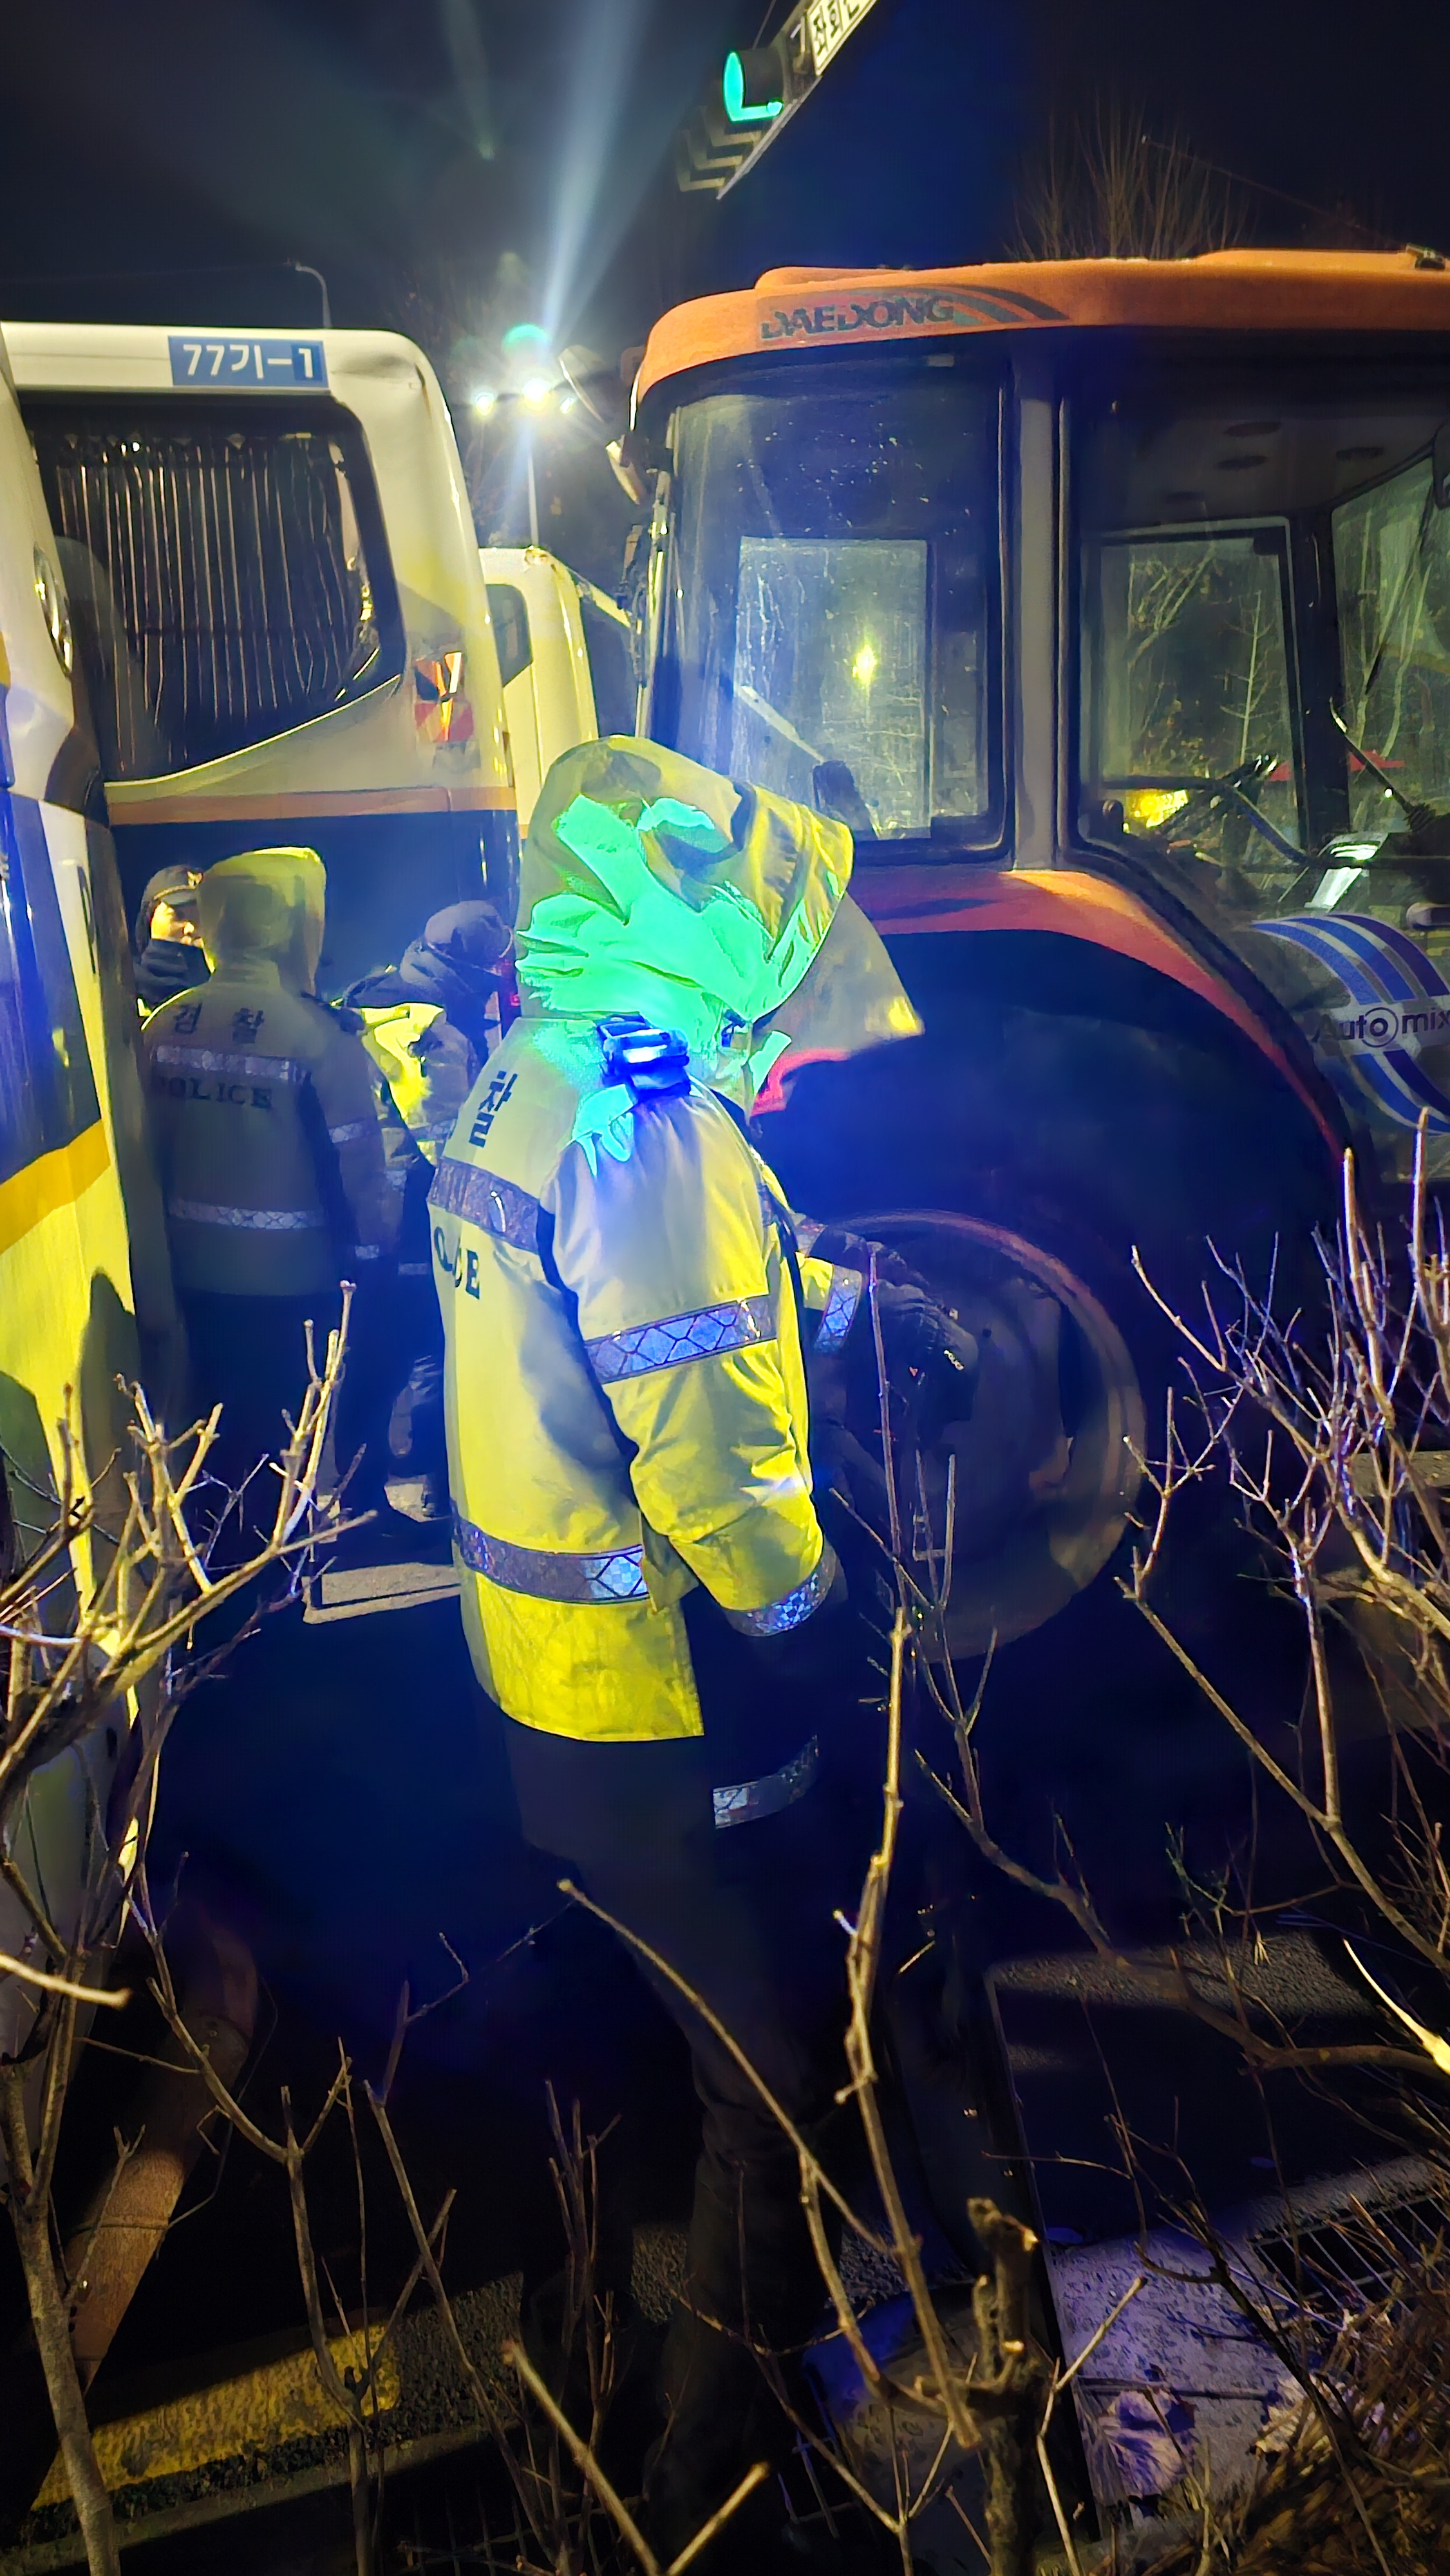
[1077,361,1450,920]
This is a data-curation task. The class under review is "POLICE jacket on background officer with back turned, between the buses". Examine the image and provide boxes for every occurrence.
[142,850,399,1296]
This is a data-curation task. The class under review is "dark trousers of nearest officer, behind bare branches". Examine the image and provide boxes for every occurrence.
[505,1641,860,2553]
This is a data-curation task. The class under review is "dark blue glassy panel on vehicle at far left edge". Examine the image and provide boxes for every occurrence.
[0,788,100,1180]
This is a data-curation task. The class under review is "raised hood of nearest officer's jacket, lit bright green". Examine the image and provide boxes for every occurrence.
[518,734,852,1079]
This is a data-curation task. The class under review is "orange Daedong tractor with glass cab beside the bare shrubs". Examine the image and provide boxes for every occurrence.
[621,252,1450,1651]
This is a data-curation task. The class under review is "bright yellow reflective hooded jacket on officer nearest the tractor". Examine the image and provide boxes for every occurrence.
[430,739,914,1741]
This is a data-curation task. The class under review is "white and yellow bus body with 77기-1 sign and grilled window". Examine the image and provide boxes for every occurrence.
[5,322,518,992]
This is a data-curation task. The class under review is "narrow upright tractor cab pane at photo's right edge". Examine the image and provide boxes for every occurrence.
[1334,456,1450,842]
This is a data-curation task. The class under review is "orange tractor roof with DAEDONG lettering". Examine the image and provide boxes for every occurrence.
[636,250,1450,402]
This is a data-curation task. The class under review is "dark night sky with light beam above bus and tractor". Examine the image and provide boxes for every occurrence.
[0,0,1450,564]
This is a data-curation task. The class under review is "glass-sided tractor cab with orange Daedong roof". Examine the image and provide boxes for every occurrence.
[628,252,1450,1195]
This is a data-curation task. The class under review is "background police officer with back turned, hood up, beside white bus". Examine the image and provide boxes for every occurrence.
[142,850,399,1535]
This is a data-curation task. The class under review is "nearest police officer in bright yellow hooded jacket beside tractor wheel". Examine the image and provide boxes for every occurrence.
[433,739,943,2566]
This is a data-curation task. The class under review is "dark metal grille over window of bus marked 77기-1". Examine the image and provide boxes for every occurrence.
[31,412,386,778]
